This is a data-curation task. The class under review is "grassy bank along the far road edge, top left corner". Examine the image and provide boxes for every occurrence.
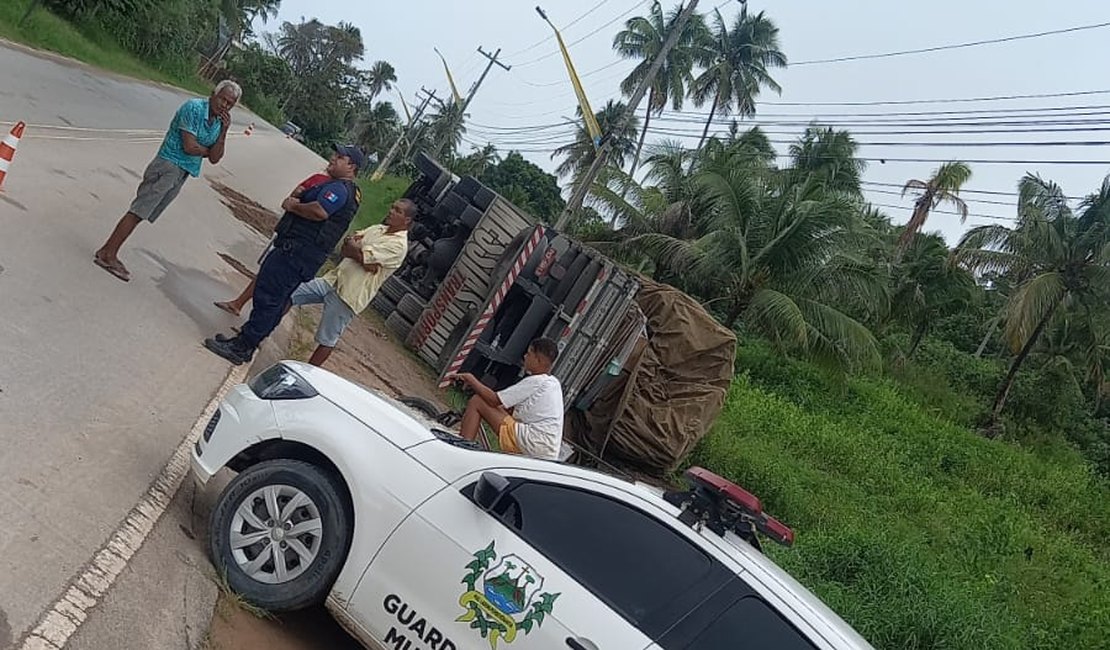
[0,0,209,94]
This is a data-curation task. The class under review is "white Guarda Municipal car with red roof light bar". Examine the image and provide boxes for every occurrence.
[193,362,870,650]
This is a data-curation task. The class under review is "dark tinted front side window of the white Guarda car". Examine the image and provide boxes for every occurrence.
[496,483,728,633]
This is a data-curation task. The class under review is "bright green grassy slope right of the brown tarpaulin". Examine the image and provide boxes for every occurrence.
[690,352,1110,650]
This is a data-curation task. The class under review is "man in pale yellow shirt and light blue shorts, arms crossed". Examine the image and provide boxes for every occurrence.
[290,199,416,366]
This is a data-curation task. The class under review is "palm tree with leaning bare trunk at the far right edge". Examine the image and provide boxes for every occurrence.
[955,175,1110,436]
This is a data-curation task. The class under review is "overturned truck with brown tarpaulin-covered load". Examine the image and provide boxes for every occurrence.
[371,154,736,474]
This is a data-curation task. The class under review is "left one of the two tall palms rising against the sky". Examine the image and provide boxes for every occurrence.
[613,0,707,174]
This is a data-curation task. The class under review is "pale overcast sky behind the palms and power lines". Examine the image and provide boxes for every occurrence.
[260,0,1110,242]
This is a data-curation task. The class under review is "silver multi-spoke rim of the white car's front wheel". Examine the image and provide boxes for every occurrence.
[229,485,323,585]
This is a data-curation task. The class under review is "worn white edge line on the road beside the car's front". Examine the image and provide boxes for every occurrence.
[19,365,249,650]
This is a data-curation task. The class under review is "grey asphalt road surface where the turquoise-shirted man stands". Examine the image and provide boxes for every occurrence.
[0,42,323,650]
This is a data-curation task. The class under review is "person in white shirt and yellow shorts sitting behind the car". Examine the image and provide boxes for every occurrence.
[456,338,563,460]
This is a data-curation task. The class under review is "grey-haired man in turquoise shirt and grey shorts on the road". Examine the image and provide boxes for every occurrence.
[93,81,243,282]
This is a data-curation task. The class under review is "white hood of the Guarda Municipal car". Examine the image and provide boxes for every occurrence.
[282,360,442,449]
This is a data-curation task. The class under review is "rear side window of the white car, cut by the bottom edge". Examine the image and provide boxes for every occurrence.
[689,596,816,650]
